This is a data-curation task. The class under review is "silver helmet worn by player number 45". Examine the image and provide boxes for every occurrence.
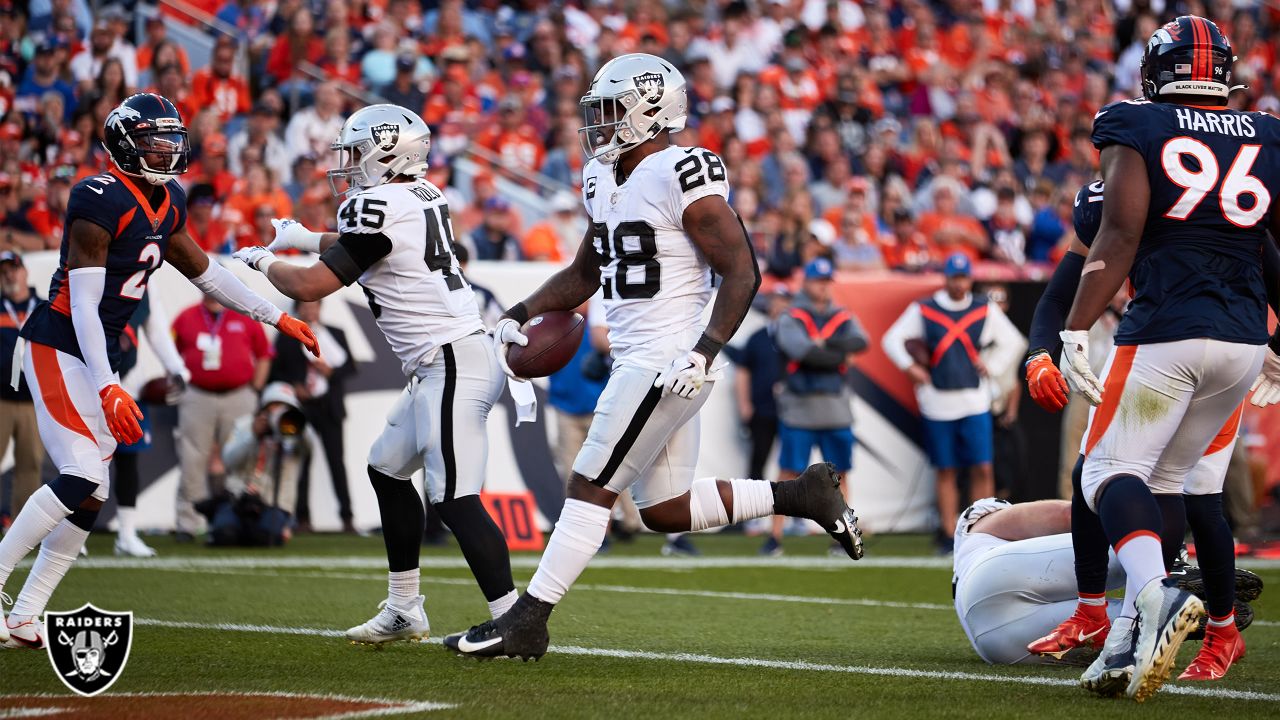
[326,105,431,196]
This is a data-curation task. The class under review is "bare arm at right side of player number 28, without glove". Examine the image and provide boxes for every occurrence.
[684,195,760,360]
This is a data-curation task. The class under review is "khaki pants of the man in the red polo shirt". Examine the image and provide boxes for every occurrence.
[177,386,256,534]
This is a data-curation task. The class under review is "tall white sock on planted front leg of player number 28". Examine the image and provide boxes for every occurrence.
[527,498,609,605]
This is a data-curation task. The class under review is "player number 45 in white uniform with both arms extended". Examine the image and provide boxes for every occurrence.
[236,105,516,643]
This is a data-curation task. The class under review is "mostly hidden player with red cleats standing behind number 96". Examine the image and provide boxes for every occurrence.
[1027,174,1280,689]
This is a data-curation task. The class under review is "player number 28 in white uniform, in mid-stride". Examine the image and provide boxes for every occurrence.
[444,54,861,659]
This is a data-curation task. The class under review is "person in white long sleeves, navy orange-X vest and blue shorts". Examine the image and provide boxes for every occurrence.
[881,252,1027,553]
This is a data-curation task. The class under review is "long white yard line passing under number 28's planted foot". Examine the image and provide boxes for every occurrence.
[124,618,1280,702]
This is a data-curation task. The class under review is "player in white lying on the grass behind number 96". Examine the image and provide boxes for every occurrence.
[951,498,1262,665]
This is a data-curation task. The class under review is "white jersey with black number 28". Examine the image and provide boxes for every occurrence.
[582,146,728,370]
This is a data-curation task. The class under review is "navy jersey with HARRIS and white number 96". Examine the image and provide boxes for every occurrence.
[1093,100,1280,345]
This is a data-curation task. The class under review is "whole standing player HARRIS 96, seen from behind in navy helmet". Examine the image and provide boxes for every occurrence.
[1061,15,1280,702]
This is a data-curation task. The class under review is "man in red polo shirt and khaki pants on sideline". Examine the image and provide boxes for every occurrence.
[173,292,272,542]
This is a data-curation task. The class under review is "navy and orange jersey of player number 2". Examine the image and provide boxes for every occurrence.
[22,170,187,372]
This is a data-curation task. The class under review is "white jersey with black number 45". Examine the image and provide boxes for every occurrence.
[320,179,484,375]
